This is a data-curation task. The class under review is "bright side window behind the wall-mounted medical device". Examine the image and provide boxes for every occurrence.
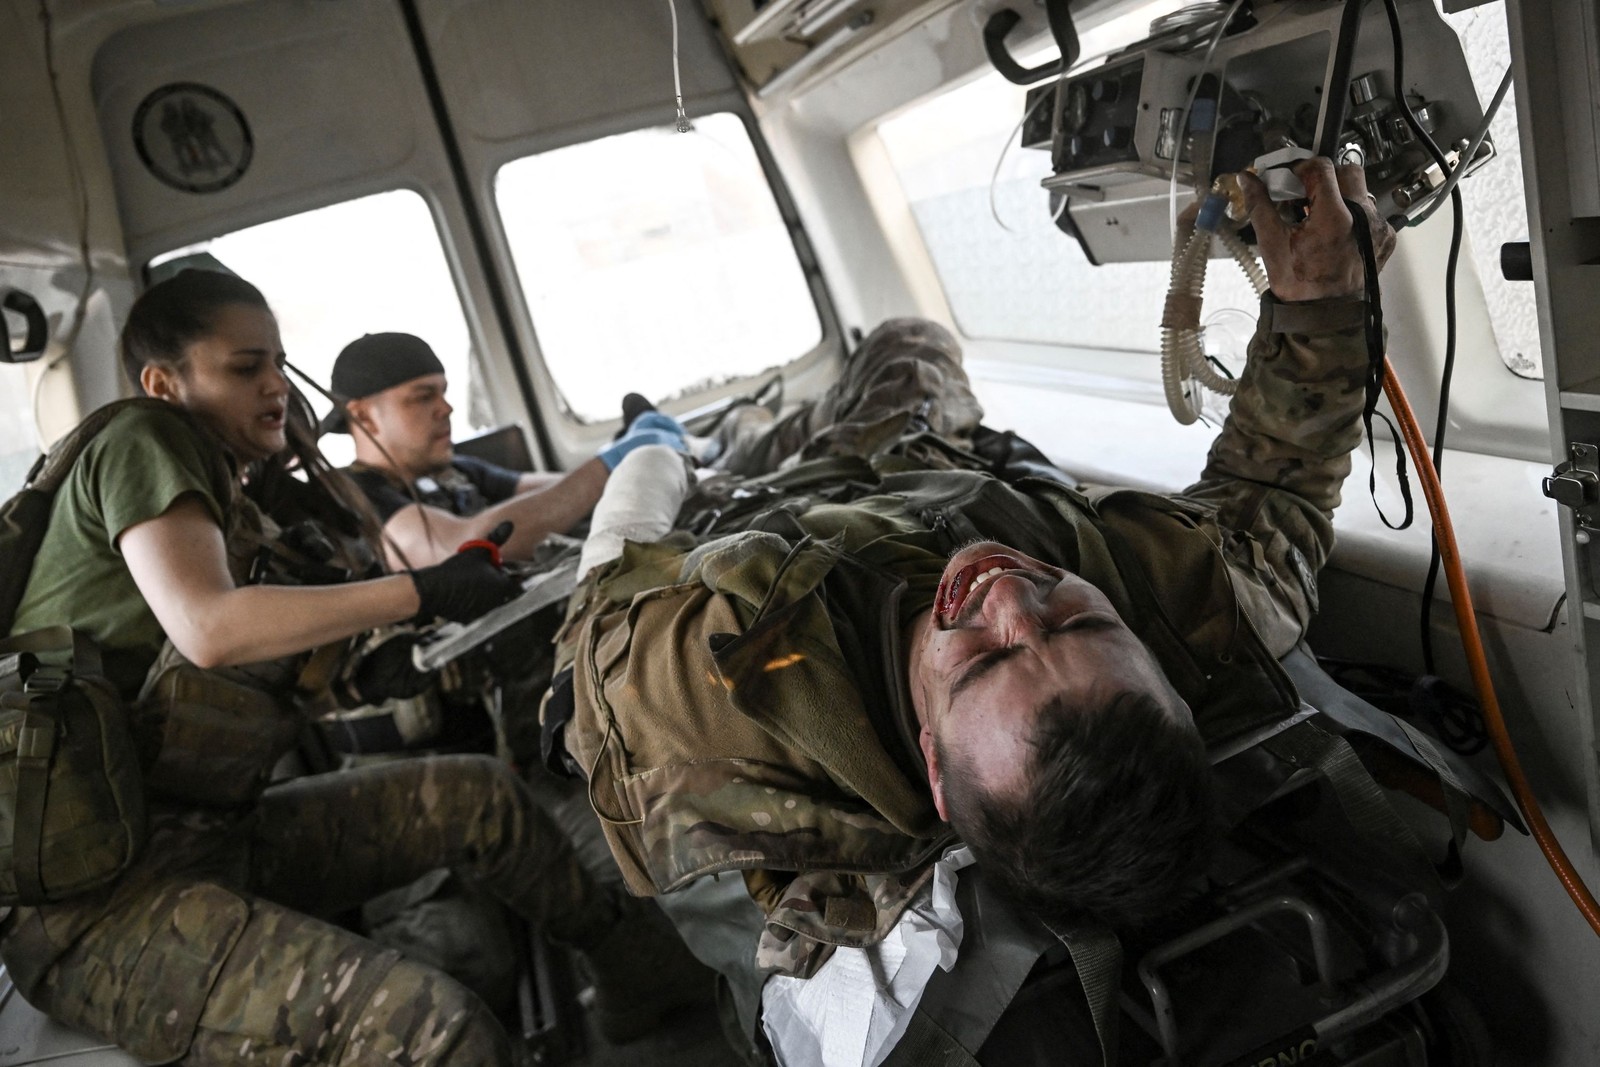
[877,5,1541,378]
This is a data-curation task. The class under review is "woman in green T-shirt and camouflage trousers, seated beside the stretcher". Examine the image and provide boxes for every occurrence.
[0,270,700,1064]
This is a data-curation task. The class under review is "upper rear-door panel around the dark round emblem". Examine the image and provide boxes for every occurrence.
[93,0,445,262]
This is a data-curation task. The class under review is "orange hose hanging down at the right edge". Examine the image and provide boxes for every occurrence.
[1384,362,1600,934]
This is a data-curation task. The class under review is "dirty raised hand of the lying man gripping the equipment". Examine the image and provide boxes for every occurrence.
[1238,157,1395,301]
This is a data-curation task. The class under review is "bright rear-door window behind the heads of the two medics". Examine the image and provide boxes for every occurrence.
[150,189,494,464]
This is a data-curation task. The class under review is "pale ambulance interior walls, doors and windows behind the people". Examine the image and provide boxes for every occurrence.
[0,0,1600,1067]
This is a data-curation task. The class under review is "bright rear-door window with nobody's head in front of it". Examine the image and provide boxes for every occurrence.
[494,114,822,419]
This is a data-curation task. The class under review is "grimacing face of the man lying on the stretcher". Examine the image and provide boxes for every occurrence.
[907,541,1192,817]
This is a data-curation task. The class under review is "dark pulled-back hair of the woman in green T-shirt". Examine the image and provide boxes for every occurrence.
[118,269,270,392]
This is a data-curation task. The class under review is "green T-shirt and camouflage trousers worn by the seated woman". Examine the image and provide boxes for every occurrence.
[0,408,616,1064]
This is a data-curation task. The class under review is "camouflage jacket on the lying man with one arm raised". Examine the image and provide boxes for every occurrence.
[557,298,1366,974]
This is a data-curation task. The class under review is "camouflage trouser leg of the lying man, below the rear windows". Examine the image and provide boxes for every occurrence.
[715,318,984,475]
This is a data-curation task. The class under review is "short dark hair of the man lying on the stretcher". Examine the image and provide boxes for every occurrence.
[939,694,1216,928]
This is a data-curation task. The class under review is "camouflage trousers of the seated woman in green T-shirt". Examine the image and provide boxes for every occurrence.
[0,757,616,1067]
